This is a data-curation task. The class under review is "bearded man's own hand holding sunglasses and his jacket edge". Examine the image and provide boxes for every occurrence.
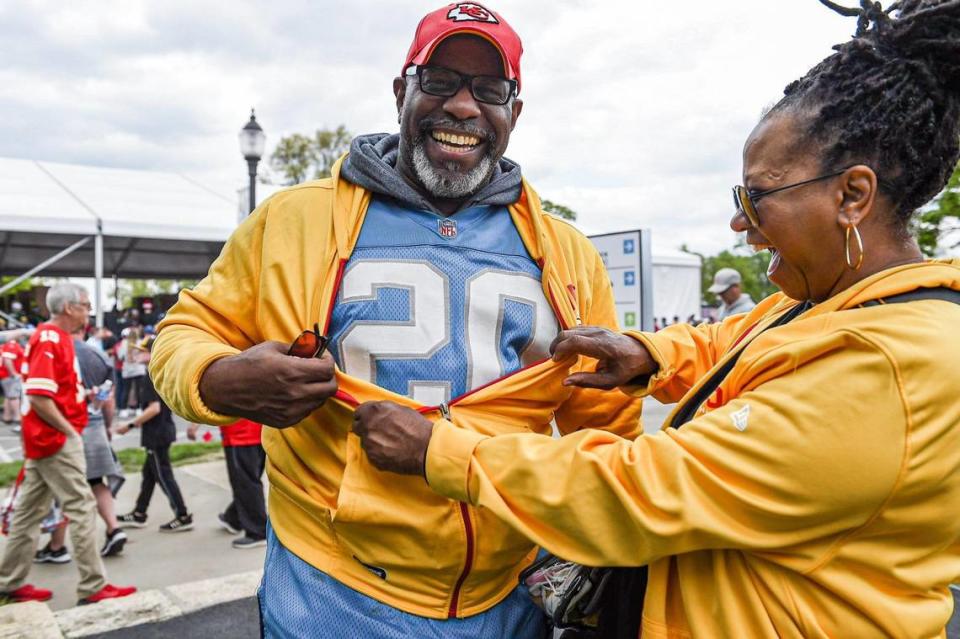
[200,342,337,428]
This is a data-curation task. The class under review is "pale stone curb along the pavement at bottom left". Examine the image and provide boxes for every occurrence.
[0,570,262,639]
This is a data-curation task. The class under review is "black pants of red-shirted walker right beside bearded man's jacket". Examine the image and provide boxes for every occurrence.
[223,444,267,539]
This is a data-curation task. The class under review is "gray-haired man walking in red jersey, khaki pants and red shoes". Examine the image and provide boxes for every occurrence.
[0,282,136,604]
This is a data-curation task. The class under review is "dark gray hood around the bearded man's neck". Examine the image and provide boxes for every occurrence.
[340,133,521,214]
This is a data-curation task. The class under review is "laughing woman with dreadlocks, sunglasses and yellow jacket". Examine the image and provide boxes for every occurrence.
[355,0,960,639]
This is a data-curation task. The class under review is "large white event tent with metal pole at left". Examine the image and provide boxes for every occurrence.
[0,158,251,322]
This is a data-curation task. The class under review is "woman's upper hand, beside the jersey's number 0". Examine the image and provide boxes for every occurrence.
[550,326,659,390]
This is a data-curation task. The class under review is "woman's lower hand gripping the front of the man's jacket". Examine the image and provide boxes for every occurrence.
[353,402,433,476]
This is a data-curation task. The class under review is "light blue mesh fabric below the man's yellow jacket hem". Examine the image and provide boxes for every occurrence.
[257,526,546,639]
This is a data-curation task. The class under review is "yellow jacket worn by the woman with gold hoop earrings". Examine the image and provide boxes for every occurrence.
[427,260,960,639]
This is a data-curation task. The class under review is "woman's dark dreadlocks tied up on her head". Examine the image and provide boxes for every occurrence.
[767,0,960,230]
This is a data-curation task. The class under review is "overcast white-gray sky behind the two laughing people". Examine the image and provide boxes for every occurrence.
[0,0,855,252]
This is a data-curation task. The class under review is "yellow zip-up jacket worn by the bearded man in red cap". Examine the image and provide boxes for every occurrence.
[150,165,640,618]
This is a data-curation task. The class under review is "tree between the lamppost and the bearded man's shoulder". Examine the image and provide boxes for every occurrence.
[270,124,352,184]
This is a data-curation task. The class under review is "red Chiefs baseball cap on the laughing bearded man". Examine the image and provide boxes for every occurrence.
[400,2,523,92]
